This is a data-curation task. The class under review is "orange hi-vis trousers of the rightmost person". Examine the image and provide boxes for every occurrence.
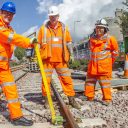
[85,75,112,100]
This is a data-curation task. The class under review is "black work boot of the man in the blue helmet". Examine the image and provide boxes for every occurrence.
[11,116,33,126]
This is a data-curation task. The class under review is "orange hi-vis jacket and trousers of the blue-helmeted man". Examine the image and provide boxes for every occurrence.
[0,17,31,119]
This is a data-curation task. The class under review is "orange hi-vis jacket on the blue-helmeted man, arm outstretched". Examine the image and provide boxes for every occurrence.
[0,17,31,69]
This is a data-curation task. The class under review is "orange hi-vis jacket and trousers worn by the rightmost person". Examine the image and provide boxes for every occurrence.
[85,34,118,100]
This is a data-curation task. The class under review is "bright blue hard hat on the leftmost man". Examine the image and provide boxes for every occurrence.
[1,2,16,14]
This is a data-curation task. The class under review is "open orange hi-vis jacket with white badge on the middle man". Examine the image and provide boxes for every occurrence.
[38,21,72,62]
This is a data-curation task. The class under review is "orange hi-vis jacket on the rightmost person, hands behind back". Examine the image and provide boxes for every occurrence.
[88,34,118,75]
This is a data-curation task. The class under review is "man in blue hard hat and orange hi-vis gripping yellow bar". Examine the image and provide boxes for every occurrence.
[0,2,37,126]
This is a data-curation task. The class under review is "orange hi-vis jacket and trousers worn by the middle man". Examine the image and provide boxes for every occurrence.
[38,21,75,96]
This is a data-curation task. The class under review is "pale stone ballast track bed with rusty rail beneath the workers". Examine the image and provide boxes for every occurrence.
[0,65,128,128]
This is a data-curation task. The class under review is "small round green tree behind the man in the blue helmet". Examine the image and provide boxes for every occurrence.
[14,47,25,61]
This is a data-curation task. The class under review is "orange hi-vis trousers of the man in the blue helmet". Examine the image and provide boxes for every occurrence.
[0,69,23,119]
